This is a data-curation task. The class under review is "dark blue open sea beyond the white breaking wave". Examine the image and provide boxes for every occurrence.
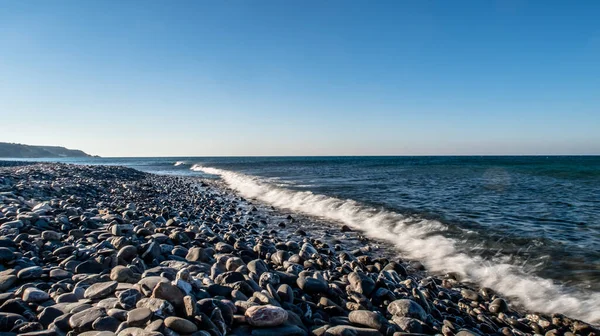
[8,156,600,320]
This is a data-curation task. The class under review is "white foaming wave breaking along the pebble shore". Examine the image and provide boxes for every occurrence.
[191,165,600,323]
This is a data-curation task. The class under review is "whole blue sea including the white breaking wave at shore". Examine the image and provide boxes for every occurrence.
[2,156,600,323]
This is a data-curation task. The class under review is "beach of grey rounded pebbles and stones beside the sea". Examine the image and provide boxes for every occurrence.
[0,161,598,336]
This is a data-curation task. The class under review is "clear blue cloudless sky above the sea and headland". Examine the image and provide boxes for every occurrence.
[0,0,600,156]
